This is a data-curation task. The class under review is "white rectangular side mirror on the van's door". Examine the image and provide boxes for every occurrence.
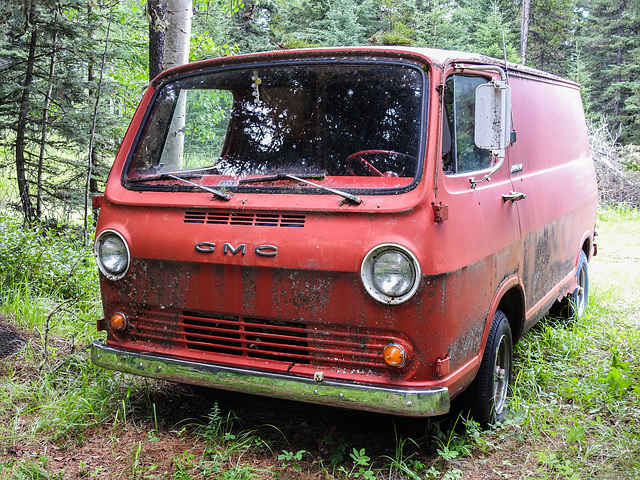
[474,80,511,159]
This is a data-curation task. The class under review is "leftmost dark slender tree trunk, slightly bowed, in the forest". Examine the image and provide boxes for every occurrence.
[16,25,38,225]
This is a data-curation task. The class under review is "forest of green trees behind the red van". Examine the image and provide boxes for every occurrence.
[0,0,640,229]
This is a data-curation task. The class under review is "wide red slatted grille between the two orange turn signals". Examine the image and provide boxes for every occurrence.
[125,312,392,375]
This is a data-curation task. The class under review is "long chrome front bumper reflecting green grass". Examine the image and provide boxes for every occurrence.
[91,340,449,417]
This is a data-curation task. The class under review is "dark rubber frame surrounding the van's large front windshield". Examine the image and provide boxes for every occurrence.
[121,56,431,195]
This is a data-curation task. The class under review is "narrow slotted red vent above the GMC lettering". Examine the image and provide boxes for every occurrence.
[184,210,305,228]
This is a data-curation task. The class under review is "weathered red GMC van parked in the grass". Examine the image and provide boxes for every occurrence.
[92,47,597,424]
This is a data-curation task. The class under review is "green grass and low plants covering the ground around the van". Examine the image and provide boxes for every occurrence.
[0,208,640,480]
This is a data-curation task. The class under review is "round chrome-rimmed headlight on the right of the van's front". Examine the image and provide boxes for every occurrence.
[360,243,421,305]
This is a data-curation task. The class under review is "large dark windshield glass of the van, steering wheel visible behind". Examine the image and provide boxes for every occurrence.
[124,59,426,193]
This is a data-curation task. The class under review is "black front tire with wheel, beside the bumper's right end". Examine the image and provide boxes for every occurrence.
[469,310,513,428]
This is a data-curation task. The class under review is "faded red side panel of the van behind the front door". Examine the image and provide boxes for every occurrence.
[507,74,597,323]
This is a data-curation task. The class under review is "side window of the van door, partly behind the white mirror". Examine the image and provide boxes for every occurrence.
[442,75,491,174]
